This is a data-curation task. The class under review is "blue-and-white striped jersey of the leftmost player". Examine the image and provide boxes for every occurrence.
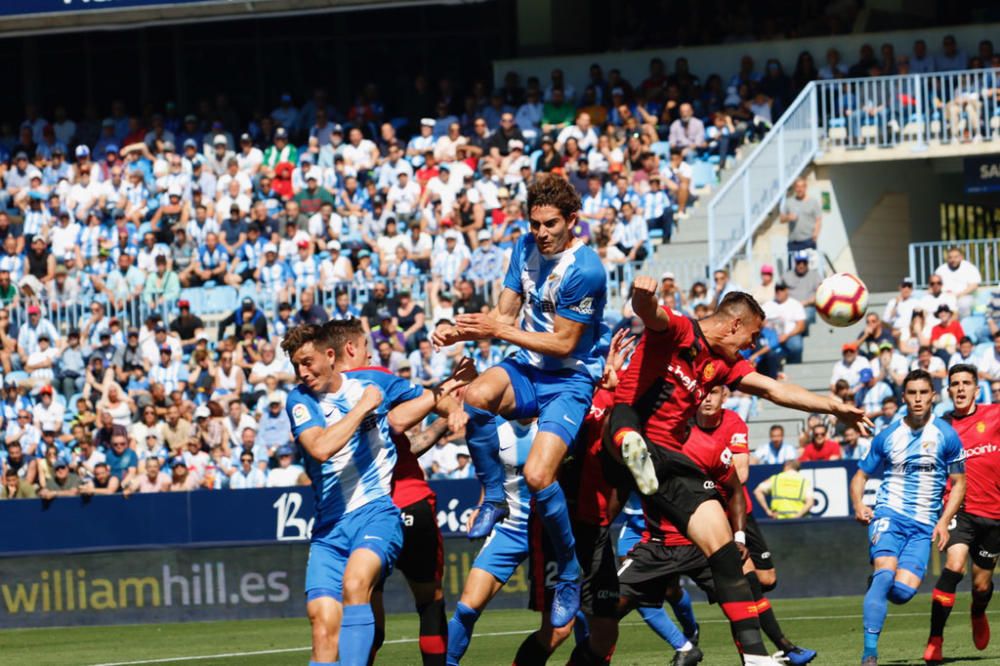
[285,370,424,532]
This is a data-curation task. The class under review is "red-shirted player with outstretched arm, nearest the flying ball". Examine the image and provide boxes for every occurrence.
[610,277,870,664]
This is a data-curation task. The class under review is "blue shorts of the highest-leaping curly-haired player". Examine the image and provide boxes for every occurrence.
[496,358,594,446]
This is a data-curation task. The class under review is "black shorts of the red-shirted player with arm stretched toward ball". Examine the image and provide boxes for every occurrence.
[646,445,722,536]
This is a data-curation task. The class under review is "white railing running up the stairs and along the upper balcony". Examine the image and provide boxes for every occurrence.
[708,68,1000,269]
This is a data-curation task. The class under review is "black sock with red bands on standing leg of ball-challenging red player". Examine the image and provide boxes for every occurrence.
[708,541,767,656]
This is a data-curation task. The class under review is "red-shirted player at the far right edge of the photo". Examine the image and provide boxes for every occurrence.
[924,363,1000,665]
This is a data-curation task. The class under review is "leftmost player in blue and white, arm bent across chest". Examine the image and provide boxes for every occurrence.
[282,325,461,666]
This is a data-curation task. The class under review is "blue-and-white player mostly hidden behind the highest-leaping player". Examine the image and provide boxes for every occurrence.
[447,417,538,666]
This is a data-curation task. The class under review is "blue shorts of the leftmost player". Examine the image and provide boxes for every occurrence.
[306,497,403,601]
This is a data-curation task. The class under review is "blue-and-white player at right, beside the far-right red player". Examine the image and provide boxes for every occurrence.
[851,370,965,666]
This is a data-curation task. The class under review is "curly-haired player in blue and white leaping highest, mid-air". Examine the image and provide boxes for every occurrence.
[433,175,607,627]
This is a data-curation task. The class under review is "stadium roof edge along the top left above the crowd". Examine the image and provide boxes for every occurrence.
[0,0,486,39]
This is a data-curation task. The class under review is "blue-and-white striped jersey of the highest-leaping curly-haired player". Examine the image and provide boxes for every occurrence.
[503,234,608,381]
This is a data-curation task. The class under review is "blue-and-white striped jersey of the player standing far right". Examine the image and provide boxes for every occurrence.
[858,416,965,525]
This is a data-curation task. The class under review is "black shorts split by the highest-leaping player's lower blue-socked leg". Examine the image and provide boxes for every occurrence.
[528,518,618,618]
